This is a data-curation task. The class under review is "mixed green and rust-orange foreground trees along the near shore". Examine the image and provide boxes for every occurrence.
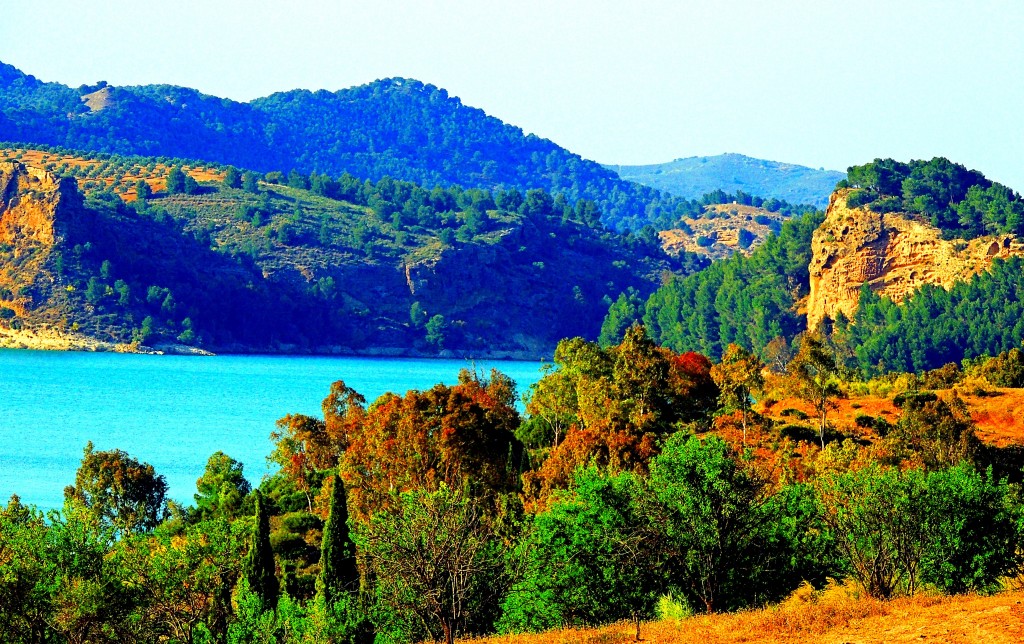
[0,326,1024,642]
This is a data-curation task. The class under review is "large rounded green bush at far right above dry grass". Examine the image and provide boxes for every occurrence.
[818,464,1019,598]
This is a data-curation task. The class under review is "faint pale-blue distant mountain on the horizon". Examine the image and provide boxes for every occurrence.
[605,154,846,208]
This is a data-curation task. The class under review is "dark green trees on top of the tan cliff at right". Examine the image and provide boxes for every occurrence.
[839,157,1024,240]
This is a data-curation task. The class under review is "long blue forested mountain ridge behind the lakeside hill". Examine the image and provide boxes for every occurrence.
[0,62,719,229]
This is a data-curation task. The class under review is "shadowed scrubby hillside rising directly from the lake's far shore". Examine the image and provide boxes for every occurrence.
[0,148,699,357]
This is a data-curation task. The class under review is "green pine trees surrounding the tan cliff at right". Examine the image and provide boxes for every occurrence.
[622,158,1024,374]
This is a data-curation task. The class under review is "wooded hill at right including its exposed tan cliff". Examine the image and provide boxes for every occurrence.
[634,158,1024,374]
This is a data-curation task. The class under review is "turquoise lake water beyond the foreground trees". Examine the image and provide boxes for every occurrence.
[0,350,540,509]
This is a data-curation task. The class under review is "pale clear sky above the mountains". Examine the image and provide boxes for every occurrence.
[0,0,1024,191]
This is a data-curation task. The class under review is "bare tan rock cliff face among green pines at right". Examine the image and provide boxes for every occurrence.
[807,189,1024,329]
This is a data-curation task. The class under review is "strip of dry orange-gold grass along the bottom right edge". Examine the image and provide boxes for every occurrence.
[465,586,1024,644]
